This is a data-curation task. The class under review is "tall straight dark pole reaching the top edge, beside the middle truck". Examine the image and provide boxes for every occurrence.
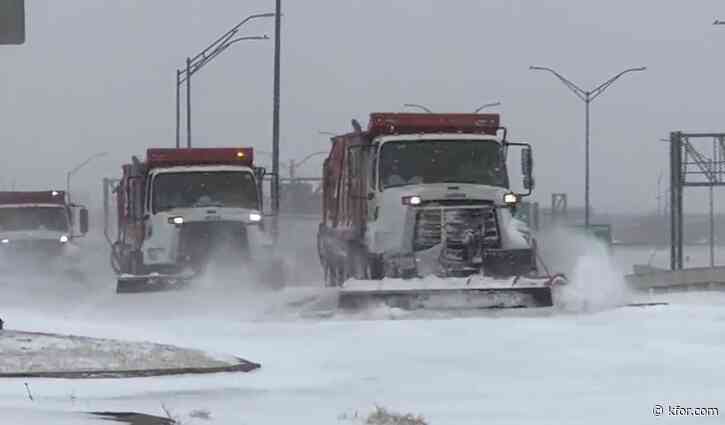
[271,0,282,241]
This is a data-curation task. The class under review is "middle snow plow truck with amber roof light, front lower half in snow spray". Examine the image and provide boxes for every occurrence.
[111,148,284,293]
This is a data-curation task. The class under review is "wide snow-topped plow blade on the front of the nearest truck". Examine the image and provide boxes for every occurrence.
[338,278,563,310]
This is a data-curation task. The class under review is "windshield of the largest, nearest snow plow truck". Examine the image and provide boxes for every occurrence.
[380,140,508,188]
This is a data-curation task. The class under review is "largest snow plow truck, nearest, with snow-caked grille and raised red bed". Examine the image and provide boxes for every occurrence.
[317,113,566,309]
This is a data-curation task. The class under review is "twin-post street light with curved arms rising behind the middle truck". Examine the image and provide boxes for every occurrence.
[176,13,276,148]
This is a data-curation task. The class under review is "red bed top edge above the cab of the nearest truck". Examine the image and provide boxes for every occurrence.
[368,112,500,137]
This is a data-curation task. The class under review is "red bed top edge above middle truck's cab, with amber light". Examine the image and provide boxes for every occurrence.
[146,148,254,168]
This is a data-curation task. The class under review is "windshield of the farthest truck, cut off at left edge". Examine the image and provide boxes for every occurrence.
[0,207,68,232]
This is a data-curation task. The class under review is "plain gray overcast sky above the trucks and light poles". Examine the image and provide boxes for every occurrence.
[0,0,725,212]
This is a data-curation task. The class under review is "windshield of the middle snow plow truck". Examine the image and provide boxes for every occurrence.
[153,171,257,212]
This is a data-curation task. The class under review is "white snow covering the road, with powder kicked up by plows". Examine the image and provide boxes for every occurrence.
[0,222,725,425]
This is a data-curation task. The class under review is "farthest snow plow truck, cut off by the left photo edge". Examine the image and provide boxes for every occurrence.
[0,190,88,275]
